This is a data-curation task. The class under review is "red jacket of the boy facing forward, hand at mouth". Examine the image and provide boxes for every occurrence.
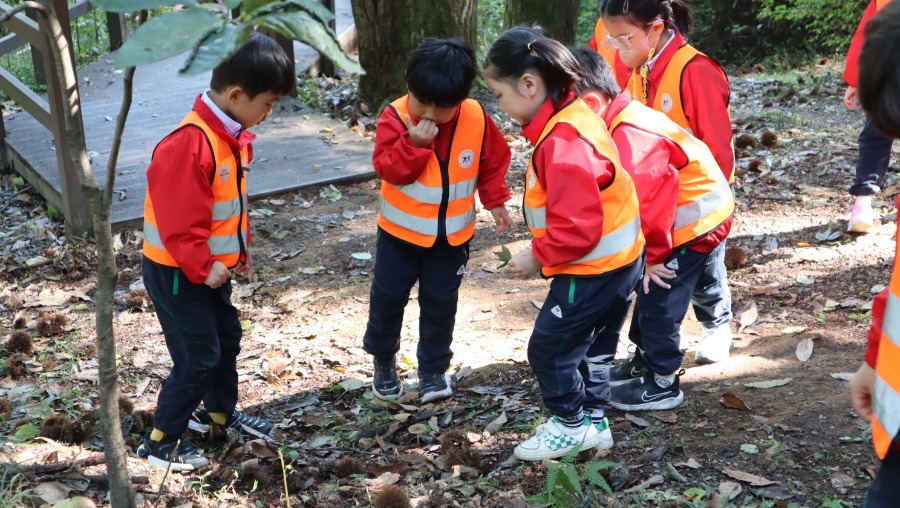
[372,99,510,210]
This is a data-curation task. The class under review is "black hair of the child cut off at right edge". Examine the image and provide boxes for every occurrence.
[859,2,900,138]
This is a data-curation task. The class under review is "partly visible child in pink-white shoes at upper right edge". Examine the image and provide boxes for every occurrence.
[844,0,894,233]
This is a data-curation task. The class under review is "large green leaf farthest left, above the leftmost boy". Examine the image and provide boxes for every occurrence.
[116,7,223,69]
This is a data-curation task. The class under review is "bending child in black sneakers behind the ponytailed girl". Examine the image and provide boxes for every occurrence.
[572,48,734,411]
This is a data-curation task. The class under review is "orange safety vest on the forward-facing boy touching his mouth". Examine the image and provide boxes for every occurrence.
[378,96,486,247]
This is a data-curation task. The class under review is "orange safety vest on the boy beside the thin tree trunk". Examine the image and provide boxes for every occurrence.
[144,111,250,268]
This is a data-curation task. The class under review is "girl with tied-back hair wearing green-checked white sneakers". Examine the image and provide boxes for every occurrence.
[484,27,644,460]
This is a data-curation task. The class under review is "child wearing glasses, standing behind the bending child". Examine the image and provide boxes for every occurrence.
[600,0,734,364]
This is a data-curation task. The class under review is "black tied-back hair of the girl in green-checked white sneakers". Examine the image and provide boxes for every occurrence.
[484,26,581,107]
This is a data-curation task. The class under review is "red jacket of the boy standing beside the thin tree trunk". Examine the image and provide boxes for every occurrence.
[147,95,256,284]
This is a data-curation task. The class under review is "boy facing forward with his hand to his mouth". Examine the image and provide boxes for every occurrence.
[363,38,516,403]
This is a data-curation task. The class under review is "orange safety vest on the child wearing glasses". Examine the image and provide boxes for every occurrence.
[627,44,734,184]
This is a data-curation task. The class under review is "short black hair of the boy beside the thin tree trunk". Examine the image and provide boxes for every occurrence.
[209,32,297,99]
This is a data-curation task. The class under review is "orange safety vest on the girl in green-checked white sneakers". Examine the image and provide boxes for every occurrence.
[523,99,644,277]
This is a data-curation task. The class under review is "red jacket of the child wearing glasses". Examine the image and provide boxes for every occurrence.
[616,30,734,181]
